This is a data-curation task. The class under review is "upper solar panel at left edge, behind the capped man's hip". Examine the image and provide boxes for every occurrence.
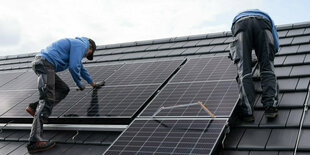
[0,70,38,90]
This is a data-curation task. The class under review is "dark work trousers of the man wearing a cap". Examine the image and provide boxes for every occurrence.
[29,56,70,143]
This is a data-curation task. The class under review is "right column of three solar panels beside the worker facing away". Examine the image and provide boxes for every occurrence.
[105,57,239,155]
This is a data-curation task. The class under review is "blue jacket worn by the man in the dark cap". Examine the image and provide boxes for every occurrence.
[37,37,93,86]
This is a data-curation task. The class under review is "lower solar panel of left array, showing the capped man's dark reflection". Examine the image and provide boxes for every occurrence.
[63,84,159,118]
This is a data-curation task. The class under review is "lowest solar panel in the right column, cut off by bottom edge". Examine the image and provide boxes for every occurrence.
[104,119,226,155]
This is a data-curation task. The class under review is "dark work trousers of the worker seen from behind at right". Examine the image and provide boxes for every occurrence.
[231,16,278,115]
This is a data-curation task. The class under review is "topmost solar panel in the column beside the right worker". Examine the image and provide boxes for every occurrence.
[171,56,237,82]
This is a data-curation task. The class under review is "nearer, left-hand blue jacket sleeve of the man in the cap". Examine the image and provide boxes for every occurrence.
[69,41,86,86]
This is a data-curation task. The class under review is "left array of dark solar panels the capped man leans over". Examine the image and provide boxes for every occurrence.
[0,60,184,118]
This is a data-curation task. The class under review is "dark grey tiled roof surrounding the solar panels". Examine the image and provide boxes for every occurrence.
[0,22,310,155]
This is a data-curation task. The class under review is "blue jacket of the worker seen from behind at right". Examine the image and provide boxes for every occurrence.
[231,9,279,53]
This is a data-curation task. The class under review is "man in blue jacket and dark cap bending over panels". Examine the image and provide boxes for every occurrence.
[26,37,100,153]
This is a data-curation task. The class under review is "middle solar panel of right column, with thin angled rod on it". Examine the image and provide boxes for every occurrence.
[140,80,239,117]
